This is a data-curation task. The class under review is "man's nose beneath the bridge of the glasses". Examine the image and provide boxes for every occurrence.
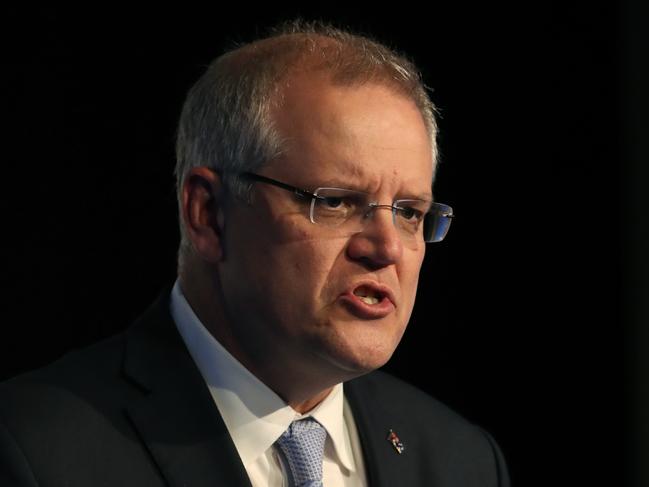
[347,205,403,268]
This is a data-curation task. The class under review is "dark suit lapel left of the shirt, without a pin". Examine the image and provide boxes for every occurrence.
[124,293,250,487]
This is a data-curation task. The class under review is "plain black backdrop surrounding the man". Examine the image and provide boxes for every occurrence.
[0,2,649,486]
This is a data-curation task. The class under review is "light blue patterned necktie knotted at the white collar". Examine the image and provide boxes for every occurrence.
[275,417,327,487]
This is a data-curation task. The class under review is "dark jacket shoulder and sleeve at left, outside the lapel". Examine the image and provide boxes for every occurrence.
[0,335,168,486]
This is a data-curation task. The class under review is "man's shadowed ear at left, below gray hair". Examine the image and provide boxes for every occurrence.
[181,167,224,263]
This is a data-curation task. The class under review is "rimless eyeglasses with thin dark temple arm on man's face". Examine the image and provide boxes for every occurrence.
[239,172,453,242]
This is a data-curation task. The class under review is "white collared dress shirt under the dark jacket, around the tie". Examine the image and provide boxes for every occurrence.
[171,281,367,487]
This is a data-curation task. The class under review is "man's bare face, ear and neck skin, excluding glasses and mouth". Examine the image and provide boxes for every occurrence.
[180,74,434,412]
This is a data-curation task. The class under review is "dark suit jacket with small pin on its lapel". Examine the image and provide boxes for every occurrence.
[0,295,509,487]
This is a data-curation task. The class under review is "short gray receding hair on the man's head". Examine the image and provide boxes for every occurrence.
[175,21,437,259]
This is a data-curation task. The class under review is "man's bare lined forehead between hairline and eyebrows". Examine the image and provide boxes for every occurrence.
[273,74,434,193]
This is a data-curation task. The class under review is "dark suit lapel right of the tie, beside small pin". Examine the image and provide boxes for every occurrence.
[345,378,416,487]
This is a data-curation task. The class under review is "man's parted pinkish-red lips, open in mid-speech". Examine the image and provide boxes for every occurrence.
[339,281,396,320]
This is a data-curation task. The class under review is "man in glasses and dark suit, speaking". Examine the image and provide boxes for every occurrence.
[0,21,508,487]
